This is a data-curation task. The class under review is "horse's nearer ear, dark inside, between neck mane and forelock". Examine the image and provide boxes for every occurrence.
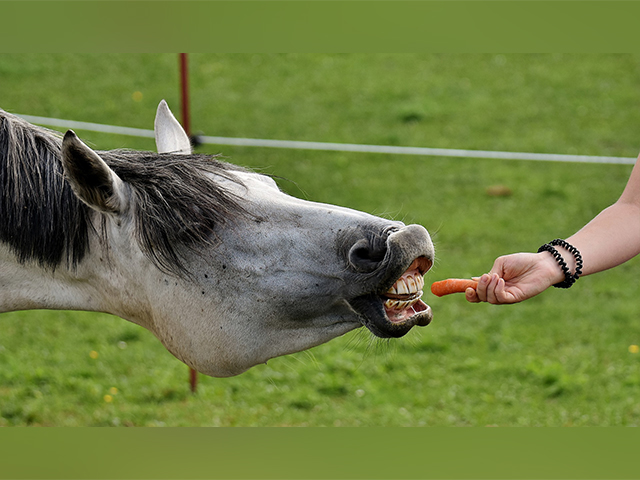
[62,130,127,214]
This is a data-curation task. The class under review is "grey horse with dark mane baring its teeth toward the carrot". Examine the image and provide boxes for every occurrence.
[0,100,434,377]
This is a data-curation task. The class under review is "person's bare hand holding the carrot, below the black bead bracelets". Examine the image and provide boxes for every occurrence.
[465,252,562,305]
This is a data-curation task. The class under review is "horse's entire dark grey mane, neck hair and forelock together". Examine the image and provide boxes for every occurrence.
[0,109,246,275]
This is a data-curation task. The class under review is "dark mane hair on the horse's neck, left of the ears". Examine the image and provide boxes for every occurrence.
[0,110,90,268]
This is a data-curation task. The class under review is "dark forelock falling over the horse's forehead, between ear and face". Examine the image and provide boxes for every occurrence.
[98,150,247,274]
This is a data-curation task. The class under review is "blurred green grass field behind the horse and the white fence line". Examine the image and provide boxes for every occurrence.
[0,54,640,426]
